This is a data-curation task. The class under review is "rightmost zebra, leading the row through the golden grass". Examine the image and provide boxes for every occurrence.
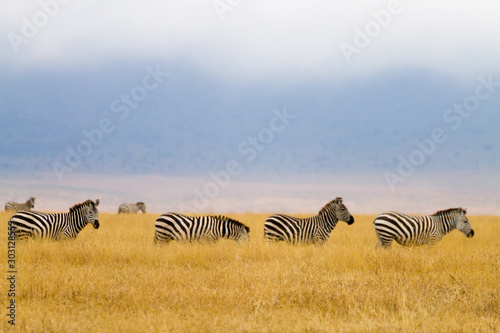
[373,208,474,248]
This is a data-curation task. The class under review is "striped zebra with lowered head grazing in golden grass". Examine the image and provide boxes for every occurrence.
[154,213,250,243]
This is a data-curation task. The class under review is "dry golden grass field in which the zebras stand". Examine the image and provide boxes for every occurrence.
[0,212,500,332]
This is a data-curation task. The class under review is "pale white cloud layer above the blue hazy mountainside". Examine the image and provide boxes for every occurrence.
[0,0,500,80]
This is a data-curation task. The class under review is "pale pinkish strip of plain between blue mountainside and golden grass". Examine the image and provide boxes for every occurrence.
[0,170,500,215]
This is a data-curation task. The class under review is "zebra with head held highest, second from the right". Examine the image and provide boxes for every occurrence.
[264,198,354,245]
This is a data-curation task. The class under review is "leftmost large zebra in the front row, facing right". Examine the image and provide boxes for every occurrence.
[9,199,99,240]
